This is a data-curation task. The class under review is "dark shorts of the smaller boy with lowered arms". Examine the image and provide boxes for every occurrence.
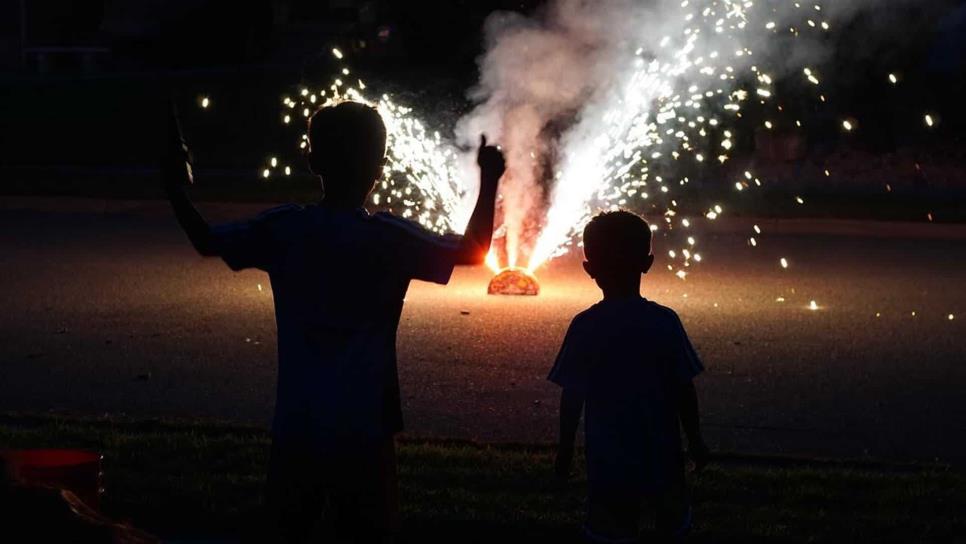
[583,467,691,544]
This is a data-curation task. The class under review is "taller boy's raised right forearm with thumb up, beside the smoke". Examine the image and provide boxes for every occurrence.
[455,136,506,264]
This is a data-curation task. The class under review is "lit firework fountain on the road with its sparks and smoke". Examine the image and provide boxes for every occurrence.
[263,0,933,294]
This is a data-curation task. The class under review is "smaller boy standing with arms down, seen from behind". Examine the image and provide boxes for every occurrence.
[548,211,708,543]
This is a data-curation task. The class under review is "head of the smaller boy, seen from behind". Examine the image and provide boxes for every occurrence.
[584,210,654,291]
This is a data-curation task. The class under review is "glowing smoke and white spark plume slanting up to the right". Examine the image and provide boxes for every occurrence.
[457,0,932,267]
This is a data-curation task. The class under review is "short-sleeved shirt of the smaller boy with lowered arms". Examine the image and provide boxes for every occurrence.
[548,297,704,493]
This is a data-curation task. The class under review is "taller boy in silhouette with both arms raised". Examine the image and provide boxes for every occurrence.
[164,102,505,542]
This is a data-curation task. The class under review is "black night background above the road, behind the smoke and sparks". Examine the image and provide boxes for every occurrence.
[0,0,966,213]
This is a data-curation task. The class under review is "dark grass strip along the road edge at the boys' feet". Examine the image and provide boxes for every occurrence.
[0,414,966,542]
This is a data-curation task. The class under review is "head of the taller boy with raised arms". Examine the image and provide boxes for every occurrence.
[308,102,386,206]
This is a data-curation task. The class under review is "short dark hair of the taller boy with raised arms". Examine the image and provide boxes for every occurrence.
[309,101,386,170]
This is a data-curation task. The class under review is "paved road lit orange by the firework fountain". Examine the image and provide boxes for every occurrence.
[0,199,966,464]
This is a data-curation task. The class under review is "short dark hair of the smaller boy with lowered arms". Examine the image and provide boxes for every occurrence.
[584,210,651,264]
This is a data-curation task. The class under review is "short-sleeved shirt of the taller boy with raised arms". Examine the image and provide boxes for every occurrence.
[212,205,459,450]
